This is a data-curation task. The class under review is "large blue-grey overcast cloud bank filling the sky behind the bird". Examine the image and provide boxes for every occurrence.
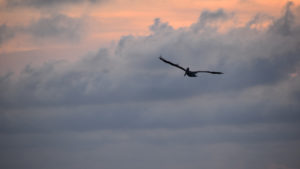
[0,1,300,169]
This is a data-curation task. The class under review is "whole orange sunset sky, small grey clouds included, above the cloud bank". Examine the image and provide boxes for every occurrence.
[0,0,299,72]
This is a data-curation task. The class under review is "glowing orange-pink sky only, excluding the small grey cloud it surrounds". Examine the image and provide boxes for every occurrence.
[0,0,300,71]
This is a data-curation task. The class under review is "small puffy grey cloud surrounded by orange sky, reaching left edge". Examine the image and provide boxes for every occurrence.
[0,14,86,44]
